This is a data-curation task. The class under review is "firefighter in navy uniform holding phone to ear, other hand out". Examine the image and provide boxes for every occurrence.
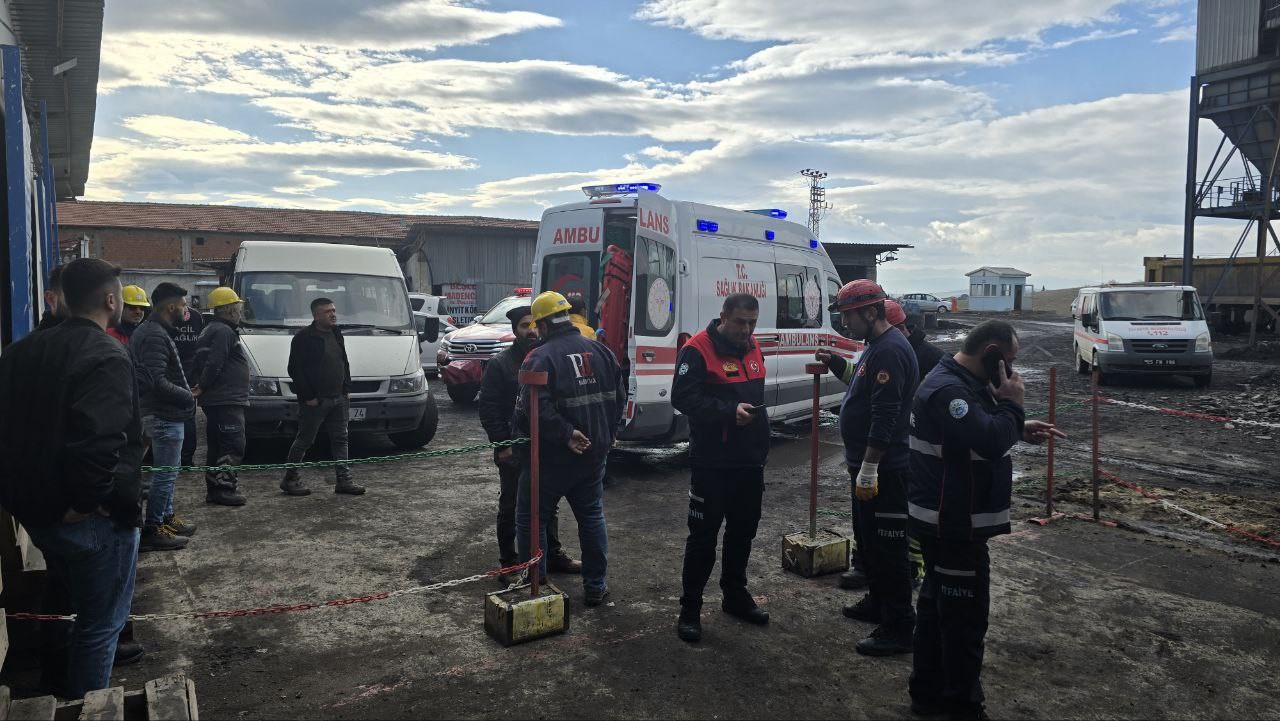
[909,320,1066,718]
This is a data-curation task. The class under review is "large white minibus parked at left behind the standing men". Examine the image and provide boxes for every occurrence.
[232,241,439,450]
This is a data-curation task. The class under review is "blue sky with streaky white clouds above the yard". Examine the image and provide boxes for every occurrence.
[84,0,1223,293]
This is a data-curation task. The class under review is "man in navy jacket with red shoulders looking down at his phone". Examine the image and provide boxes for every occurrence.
[671,293,769,643]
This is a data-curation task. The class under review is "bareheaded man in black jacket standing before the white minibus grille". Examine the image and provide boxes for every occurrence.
[280,298,365,496]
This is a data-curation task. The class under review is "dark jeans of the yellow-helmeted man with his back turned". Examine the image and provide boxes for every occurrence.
[516,462,609,590]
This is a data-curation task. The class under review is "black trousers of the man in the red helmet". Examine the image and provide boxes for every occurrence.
[849,469,915,633]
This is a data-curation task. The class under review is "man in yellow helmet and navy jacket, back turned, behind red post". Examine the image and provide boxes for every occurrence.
[512,291,627,606]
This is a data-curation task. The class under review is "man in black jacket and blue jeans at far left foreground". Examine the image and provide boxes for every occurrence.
[0,259,142,698]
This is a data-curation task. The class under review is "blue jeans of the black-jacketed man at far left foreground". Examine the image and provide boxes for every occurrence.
[27,517,139,698]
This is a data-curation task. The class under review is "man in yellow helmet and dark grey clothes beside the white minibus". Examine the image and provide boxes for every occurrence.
[193,288,250,506]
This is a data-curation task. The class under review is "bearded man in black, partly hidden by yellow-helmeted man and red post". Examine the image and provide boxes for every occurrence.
[480,305,582,584]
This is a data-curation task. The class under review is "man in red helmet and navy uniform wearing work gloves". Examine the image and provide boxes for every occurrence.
[827,279,919,656]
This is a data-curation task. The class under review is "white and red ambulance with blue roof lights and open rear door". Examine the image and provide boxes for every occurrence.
[532,183,861,443]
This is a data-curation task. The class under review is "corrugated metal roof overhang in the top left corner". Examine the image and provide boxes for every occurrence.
[8,0,102,198]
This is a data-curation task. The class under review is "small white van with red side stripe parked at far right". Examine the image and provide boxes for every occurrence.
[1071,283,1213,388]
